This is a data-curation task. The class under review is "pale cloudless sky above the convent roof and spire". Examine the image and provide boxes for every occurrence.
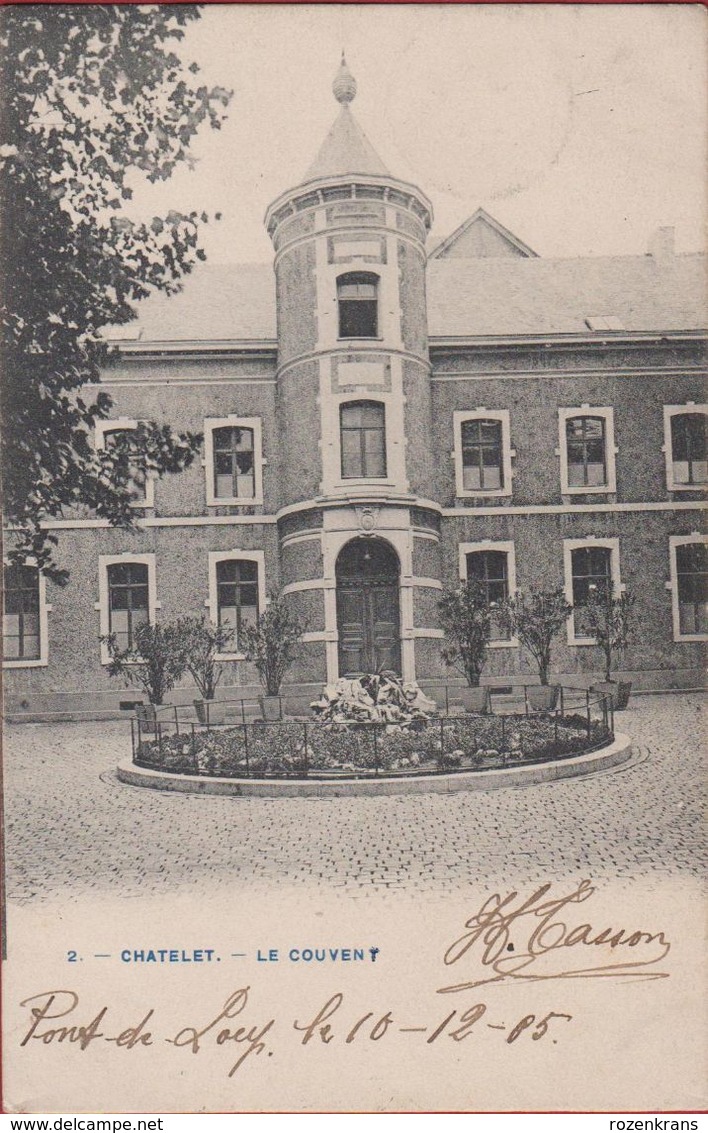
[129,5,708,263]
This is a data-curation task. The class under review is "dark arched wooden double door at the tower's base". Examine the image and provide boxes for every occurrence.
[335,538,401,676]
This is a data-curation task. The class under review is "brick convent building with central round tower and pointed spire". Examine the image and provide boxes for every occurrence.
[5,55,708,715]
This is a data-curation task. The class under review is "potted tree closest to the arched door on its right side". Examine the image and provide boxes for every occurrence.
[437,579,497,713]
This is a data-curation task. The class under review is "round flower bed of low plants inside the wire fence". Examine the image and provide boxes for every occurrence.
[135,715,612,778]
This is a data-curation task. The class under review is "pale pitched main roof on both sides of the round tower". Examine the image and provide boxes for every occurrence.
[110,254,707,343]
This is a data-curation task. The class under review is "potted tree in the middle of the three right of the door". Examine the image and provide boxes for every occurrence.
[498,587,573,712]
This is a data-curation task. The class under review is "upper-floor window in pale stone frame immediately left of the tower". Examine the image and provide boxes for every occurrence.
[204,417,264,506]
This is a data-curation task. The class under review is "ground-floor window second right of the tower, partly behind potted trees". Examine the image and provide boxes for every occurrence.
[564,539,621,645]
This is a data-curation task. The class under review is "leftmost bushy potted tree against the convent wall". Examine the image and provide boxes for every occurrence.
[101,622,187,732]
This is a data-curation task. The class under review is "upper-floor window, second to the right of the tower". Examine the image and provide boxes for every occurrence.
[558,406,616,495]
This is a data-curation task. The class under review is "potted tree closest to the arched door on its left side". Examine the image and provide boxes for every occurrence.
[241,595,307,721]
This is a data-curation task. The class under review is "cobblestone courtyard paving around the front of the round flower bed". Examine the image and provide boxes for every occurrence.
[5,695,706,902]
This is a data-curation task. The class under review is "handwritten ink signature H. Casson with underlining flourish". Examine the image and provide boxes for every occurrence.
[437,880,671,994]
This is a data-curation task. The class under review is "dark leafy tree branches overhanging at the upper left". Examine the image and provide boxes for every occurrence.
[0,5,230,582]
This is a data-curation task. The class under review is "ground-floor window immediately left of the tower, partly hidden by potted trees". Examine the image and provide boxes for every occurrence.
[206,551,265,659]
